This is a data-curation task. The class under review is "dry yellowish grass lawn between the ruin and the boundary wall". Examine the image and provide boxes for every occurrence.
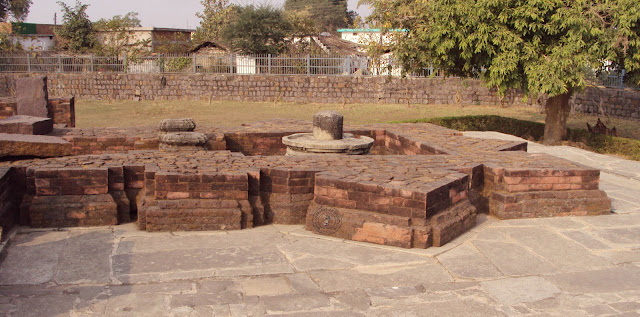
[76,100,640,139]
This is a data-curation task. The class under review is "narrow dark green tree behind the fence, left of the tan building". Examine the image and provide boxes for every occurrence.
[55,1,96,52]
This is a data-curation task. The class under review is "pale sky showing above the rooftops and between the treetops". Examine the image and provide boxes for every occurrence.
[26,0,370,29]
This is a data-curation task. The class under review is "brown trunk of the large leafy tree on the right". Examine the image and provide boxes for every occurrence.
[543,90,572,144]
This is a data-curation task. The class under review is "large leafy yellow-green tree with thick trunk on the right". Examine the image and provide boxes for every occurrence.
[371,0,640,144]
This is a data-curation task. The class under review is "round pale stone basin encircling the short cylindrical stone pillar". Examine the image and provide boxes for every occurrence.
[282,133,373,155]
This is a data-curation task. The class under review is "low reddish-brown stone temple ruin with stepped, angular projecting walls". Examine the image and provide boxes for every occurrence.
[0,76,611,248]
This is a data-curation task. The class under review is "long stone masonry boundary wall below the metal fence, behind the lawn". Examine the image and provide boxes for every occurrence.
[0,73,640,120]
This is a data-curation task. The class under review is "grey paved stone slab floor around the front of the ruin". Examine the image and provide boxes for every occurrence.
[0,133,640,317]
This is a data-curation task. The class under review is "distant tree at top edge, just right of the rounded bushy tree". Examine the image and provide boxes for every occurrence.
[284,0,357,32]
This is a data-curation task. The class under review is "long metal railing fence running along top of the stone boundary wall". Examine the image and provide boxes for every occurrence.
[0,52,439,76]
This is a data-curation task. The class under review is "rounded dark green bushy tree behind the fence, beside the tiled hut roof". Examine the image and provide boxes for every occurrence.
[222,5,291,54]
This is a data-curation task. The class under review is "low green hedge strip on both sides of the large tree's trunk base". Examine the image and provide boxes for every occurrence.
[401,115,640,161]
